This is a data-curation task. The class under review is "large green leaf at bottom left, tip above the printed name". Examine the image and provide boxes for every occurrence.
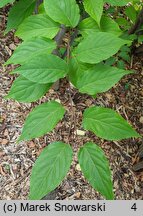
[29,142,73,200]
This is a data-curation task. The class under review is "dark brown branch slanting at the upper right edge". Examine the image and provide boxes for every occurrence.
[128,7,143,35]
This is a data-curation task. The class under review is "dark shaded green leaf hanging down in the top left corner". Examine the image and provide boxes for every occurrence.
[5,0,36,33]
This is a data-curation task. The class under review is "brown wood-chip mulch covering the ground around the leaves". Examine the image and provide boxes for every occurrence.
[0,7,143,200]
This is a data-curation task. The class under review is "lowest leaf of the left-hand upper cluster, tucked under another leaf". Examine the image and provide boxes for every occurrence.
[5,76,52,103]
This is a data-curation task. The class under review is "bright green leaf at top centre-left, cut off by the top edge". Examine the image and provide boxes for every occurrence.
[44,0,80,28]
